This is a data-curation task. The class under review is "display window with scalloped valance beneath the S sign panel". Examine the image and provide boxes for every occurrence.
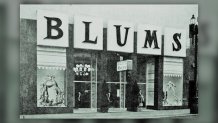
[163,58,183,106]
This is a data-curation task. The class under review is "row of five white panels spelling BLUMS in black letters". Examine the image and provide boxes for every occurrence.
[37,10,186,57]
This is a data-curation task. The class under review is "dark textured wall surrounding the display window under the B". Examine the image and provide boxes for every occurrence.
[20,19,73,114]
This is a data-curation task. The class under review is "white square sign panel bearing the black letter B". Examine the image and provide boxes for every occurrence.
[37,10,69,47]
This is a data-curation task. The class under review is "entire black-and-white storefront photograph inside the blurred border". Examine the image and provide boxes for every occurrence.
[19,4,199,119]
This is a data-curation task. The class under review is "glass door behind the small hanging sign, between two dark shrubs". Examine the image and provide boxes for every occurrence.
[106,53,126,112]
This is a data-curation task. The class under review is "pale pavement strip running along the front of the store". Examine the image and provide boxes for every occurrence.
[20,109,198,119]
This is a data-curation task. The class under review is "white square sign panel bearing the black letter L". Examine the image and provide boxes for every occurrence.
[74,16,103,50]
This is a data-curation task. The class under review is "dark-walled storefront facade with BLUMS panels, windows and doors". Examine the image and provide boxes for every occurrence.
[20,6,195,114]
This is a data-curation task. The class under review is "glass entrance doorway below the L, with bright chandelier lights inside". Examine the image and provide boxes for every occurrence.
[73,51,97,113]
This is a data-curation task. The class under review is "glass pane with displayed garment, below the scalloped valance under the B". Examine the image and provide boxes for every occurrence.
[37,68,66,107]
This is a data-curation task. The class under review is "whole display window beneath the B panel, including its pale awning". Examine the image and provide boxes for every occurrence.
[37,46,67,107]
